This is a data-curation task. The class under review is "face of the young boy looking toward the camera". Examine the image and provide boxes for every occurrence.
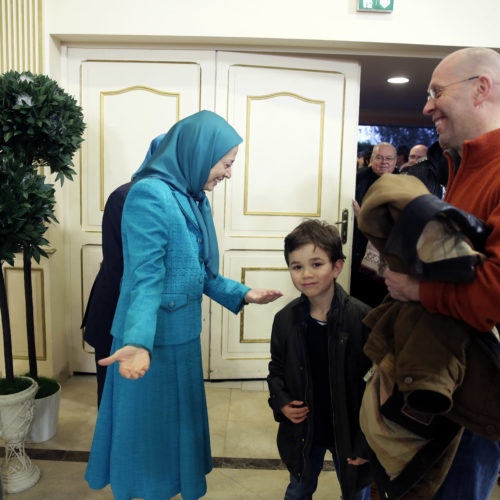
[288,243,344,299]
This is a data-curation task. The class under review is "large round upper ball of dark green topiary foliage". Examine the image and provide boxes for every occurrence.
[0,71,85,184]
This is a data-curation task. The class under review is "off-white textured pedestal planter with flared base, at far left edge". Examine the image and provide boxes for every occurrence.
[0,377,40,493]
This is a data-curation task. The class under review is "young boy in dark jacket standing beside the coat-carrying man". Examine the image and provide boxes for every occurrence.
[267,220,371,500]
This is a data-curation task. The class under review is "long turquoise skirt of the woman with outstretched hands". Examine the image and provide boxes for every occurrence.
[85,337,212,500]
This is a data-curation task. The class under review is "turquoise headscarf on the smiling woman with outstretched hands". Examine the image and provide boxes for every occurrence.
[133,111,243,278]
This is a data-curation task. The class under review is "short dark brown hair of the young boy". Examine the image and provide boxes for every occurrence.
[285,219,345,265]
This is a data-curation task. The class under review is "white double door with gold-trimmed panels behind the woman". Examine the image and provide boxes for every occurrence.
[63,48,359,379]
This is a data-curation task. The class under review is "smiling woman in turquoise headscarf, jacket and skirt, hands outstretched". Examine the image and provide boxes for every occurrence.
[85,111,281,500]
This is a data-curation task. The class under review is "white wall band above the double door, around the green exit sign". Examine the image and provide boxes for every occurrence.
[44,0,500,52]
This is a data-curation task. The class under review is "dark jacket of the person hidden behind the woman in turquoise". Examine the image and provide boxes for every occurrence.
[82,182,132,354]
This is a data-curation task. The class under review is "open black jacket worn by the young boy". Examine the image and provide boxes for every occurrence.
[267,283,371,500]
